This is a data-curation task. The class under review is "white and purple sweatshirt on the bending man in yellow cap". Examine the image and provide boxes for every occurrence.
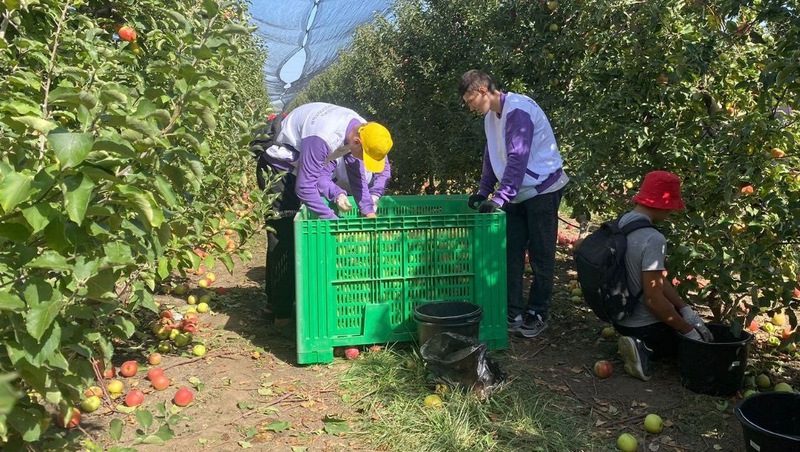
[267,102,375,219]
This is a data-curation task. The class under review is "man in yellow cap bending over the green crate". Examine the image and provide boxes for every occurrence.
[251,102,392,318]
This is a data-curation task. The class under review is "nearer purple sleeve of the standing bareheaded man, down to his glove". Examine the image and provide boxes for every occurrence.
[492,110,533,206]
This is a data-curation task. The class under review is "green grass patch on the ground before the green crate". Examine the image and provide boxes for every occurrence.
[341,349,596,452]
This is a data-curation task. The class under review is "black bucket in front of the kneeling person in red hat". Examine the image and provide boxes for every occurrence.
[678,324,753,396]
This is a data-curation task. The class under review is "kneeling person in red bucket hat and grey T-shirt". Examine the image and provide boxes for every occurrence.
[614,171,713,381]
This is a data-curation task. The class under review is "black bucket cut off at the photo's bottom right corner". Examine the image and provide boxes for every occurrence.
[734,392,800,452]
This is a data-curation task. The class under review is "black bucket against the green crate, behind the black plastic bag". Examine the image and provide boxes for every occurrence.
[414,301,483,345]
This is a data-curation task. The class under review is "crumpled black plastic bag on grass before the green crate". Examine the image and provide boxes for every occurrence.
[420,332,506,398]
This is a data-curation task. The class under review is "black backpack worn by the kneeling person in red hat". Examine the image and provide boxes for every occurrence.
[574,219,654,323]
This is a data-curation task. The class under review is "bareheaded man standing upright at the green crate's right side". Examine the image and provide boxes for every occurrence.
[459,69,569,338]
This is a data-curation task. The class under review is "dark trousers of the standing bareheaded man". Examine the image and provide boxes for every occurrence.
[503,189,564,319]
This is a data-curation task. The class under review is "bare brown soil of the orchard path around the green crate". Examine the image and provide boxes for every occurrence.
[82,221,800,451]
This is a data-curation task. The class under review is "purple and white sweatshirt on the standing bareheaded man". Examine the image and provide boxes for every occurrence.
[478,93,569,206]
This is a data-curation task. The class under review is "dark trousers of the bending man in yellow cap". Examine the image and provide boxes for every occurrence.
[264,173,300,318]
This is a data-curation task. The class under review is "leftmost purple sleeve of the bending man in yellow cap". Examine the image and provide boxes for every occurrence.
[295,136,337,220]
